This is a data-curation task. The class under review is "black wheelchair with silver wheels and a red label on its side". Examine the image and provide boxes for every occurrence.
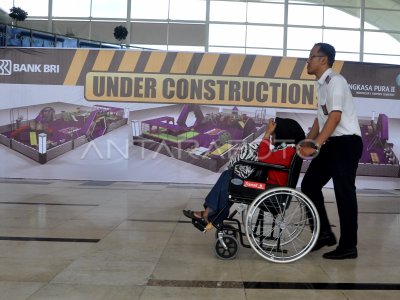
[192,155,320,263]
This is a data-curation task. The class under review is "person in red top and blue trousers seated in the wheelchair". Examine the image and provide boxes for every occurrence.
[183,118,305,224]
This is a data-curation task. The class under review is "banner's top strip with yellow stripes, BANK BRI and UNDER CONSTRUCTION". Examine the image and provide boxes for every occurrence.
[0,48,400,109]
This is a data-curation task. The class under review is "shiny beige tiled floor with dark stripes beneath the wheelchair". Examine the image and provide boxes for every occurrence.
[0,179,400,300]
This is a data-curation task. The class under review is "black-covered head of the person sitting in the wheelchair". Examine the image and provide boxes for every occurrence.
[275,118,306,146]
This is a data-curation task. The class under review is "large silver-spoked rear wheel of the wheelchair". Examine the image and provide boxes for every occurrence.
[246,187,320,263]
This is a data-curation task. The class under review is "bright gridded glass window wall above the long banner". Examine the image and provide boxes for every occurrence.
[0,0,400,64]
